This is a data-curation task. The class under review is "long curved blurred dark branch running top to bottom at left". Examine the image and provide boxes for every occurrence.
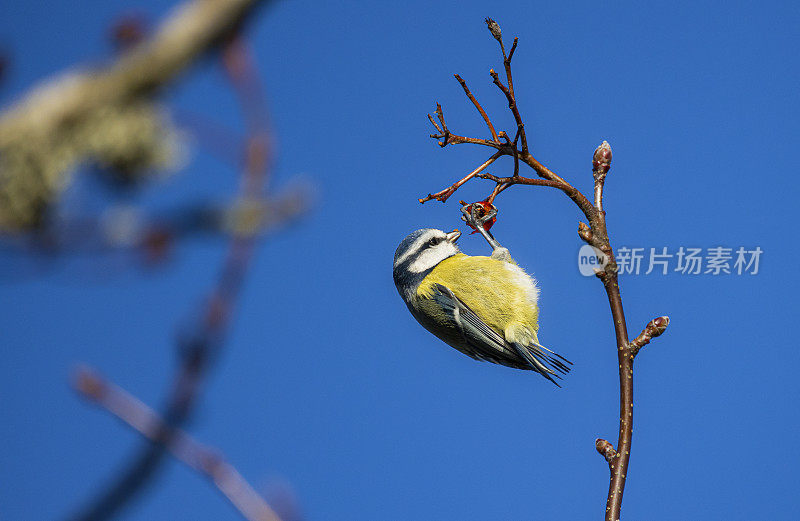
[63,8,288,521]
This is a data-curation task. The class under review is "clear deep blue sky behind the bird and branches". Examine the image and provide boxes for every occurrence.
[0,0,800,521]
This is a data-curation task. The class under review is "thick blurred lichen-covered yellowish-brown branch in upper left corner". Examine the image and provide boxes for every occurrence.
[0,0,264,231]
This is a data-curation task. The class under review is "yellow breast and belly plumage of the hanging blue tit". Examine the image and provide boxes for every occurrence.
[417,253,539,337]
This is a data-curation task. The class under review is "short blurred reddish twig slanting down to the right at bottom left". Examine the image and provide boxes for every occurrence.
[73,367,280,521]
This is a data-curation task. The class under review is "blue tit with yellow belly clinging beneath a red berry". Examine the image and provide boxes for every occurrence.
[393,205,572,387]
